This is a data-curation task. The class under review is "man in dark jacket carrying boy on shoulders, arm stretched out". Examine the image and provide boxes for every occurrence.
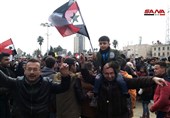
[97,63,166,118]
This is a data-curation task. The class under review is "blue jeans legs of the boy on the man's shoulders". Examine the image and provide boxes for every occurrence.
[93,73,128,94]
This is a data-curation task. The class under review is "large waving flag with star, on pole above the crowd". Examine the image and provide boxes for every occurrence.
[49,0,90,39]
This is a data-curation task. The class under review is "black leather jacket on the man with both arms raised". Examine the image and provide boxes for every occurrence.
[0,71,70,118]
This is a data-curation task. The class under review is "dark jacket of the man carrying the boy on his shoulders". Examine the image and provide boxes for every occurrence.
[98,78,154,118]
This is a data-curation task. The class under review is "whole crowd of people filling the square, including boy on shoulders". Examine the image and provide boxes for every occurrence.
[0,36,170,118]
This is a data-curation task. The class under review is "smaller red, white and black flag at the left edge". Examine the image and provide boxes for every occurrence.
[0,38,17,55]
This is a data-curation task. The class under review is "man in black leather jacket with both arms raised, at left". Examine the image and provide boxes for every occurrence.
[0,59,70,118]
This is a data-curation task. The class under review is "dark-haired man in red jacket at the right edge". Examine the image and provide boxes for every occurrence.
[150,61,170,118]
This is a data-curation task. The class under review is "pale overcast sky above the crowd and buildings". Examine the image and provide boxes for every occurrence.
[0,0,170,54]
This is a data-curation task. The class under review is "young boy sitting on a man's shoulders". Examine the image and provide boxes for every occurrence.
[93,36,128,94]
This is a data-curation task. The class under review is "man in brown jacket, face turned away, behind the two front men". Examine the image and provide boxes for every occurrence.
[54,57,82,118]
